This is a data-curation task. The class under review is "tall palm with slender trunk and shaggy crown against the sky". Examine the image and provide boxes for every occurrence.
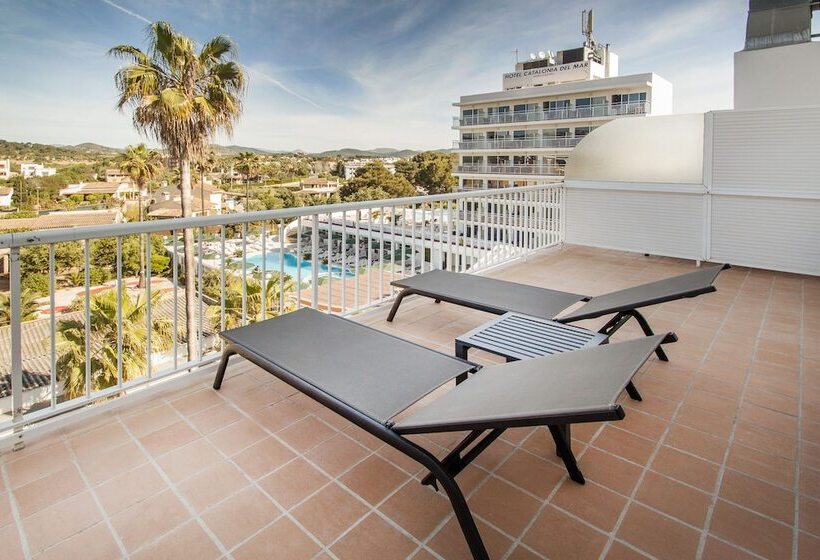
[109,21,245,360]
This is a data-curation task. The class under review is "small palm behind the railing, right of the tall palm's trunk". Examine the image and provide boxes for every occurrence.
[208,272,296,329]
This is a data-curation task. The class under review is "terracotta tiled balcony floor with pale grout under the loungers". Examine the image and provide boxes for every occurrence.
[0,247,820,560]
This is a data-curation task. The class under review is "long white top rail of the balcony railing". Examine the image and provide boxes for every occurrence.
[0,184,558,249]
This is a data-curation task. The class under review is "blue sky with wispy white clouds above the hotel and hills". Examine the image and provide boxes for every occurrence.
[0,0,748,152]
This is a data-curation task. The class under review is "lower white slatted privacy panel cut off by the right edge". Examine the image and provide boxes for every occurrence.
[711,195,820,275]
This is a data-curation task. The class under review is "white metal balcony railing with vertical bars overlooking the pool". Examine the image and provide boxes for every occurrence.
[0,185,563,434]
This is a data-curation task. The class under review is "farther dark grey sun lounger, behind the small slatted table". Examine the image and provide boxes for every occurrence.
[387,264,729,361]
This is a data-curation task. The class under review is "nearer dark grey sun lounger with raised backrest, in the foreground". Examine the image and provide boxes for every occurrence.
[214,308,666,560]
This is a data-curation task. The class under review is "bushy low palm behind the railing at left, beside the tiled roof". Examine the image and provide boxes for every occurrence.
[57,290,174,399]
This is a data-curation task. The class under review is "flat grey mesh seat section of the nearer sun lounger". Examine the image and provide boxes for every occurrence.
[222,308,474,422]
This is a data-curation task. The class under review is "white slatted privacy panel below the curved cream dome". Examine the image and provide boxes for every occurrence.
[565,185,705,260]
